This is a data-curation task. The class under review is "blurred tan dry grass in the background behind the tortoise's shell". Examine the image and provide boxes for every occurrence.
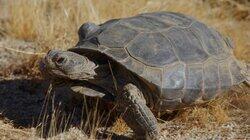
[2,0,250,61]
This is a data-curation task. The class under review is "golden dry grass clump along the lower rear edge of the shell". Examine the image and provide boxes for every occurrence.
[174,86,250,127]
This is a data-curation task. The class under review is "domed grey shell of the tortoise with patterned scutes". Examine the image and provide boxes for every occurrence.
[71,12,245,103]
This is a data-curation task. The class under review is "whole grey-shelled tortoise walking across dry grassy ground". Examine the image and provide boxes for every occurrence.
[40,12,249,139]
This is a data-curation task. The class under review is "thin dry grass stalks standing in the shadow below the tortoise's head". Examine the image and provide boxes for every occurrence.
[36,92,109,139]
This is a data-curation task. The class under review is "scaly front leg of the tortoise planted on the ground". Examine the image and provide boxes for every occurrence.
[117,84,158,139]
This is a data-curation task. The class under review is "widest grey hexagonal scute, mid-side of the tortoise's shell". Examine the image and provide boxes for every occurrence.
[127,33,178,67]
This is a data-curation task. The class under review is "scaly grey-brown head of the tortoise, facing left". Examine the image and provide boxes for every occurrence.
[40,50,97,80]
